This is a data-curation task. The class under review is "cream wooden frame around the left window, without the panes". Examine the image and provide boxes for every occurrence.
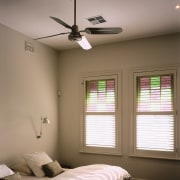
[80,71,122,155]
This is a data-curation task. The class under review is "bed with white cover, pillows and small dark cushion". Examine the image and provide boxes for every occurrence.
[0,152,131,180]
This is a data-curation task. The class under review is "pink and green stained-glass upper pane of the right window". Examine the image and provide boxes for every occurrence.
[137,75,173,112]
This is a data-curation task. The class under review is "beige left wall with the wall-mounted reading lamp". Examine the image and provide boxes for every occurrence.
[0,25,58,163]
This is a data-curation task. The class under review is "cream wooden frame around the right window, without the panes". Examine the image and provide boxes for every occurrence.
[130,66,180,160]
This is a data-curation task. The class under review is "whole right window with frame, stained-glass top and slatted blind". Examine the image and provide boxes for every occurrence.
[132,67,177,158]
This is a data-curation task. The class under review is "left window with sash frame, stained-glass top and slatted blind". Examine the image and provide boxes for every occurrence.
[82,74,120,154]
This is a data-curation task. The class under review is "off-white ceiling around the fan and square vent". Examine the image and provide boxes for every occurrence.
[0,0,180,50]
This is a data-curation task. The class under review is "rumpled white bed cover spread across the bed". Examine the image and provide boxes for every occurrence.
[22,164,130,180]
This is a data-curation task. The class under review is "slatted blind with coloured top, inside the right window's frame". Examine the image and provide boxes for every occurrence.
[136,74,175,152]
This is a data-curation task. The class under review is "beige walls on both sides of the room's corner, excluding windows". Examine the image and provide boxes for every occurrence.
[0,22,180,180]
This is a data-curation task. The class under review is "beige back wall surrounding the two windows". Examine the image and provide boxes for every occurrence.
[59,35,180,180]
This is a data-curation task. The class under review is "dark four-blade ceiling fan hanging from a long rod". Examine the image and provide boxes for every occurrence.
[35,0,122,50]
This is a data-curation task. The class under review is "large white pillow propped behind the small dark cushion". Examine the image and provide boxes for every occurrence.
[23,152,52,177]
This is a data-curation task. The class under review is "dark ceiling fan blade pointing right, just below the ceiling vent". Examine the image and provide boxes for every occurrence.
[85,27,122,34]
